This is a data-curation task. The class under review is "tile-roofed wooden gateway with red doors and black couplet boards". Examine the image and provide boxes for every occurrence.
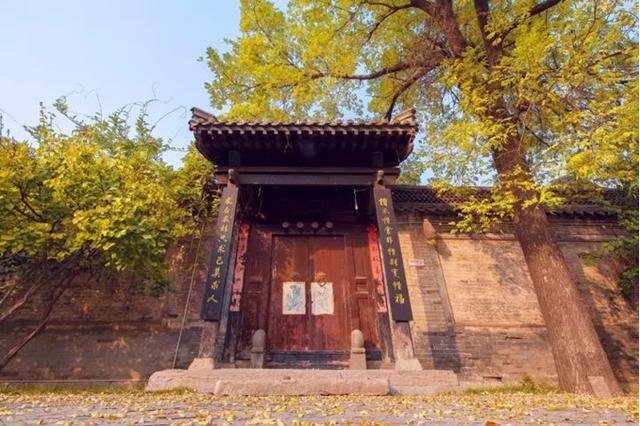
[190,110,428,369]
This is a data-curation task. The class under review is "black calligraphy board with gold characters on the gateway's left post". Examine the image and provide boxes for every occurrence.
[201,183,238,321]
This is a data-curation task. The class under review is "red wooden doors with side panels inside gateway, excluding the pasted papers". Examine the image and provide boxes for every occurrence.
[236,225,386,368]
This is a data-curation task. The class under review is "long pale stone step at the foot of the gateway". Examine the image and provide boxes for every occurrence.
[146,368,462,396]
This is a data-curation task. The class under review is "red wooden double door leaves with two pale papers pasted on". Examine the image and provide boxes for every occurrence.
[267,235,351,351]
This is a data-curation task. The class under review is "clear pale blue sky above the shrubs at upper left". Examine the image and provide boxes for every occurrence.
[0,0,283,165]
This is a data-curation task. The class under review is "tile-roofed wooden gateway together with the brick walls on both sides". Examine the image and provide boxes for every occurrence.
[0,109,638,390]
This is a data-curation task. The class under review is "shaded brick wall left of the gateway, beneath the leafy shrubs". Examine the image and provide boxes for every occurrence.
[0,235,212,380]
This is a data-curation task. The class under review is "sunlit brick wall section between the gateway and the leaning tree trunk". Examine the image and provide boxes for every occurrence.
[400,221,556,382]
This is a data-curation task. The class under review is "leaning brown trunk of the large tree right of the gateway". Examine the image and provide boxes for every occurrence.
[424,0,621,396]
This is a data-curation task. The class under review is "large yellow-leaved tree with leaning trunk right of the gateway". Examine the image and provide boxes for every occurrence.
[203,0,638,394]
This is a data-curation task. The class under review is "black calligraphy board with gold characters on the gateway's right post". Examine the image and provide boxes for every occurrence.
[373,185,413,321]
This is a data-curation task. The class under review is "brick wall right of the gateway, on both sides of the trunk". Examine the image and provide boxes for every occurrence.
[399,215,638,389]
